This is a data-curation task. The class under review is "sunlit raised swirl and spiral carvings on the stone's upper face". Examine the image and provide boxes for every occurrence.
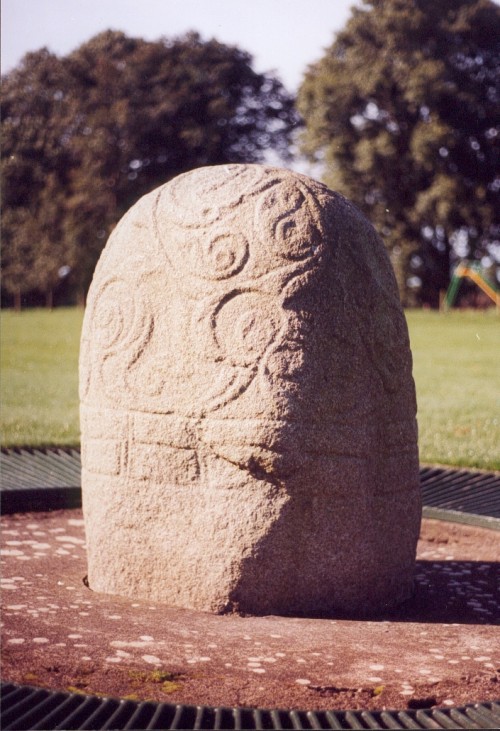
[83,166,324,415]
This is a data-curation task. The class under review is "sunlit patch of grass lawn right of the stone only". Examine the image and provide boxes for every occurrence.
[406,310,500,470]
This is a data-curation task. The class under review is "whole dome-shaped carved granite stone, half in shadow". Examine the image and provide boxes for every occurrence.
[80,165,421,613]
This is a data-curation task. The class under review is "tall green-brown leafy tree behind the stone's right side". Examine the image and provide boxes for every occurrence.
[298,0,500,306]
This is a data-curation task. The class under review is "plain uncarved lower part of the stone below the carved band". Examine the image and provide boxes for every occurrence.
[82,460,420,616]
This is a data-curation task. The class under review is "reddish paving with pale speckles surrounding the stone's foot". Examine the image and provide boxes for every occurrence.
[1,510,500,710]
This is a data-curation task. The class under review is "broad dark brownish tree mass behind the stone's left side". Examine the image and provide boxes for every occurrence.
[2,31,299,306]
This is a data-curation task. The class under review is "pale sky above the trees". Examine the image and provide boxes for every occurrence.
[1,0,362,91]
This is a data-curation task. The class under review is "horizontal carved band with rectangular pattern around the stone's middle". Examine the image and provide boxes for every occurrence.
[82,408,415,479]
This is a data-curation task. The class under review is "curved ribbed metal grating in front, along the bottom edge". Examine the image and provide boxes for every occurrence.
[1,683,500,731]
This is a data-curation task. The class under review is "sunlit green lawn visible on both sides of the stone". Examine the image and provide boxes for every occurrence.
[0,309,500,470]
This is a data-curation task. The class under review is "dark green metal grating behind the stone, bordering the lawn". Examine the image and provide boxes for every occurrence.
[0,447,500,530]
